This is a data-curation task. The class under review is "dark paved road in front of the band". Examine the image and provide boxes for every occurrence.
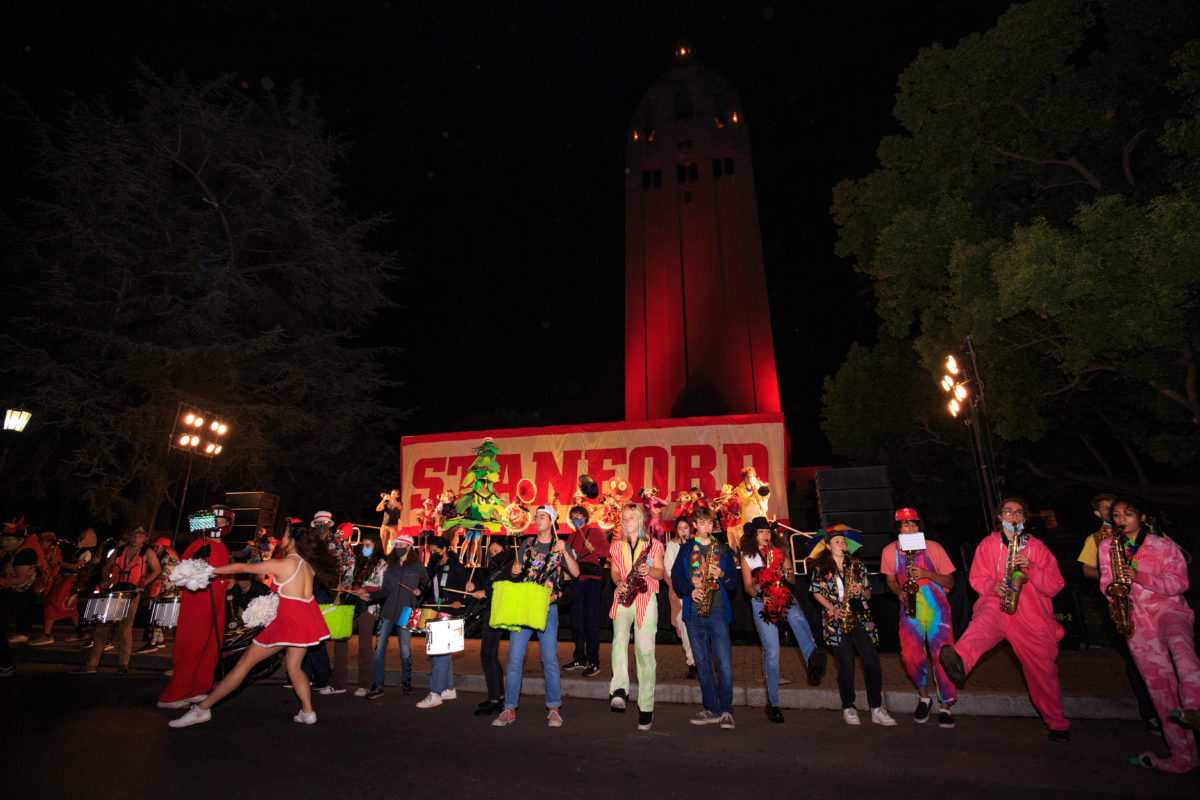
[0,666,1200,800]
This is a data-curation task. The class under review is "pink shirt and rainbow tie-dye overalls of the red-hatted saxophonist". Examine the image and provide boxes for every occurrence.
[880,541,958,705]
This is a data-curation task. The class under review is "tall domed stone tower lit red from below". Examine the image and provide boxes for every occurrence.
[625,48,780,420]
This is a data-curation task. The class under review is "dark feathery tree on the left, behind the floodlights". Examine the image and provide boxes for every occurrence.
[0,73,395,524]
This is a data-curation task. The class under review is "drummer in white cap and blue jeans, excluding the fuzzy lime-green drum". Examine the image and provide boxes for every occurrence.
[492,505,580,728]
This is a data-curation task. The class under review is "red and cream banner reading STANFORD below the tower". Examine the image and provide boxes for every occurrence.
[400,414,788,525]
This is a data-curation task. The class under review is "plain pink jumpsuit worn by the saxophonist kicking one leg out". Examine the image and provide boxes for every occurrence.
[954,531,1070,730]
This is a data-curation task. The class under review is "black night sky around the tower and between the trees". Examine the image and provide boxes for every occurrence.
[7,0,1022,464]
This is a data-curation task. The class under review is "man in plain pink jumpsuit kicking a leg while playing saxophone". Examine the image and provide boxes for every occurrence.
[938,498,1070,741]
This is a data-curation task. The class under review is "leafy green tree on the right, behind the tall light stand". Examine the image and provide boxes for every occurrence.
[823,0,1200,510]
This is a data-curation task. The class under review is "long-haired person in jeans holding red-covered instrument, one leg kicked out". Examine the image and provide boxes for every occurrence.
[742,517,826,722]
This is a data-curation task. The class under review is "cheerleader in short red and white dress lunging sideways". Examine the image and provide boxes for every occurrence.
[168,525,337,728]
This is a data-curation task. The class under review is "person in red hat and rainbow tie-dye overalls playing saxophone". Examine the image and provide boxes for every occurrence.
[880,509,958,728]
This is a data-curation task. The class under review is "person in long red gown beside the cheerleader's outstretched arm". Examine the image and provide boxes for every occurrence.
[158,505,233,709]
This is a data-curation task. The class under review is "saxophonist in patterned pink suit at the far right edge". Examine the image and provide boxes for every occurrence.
[1099,498,1200,772]
